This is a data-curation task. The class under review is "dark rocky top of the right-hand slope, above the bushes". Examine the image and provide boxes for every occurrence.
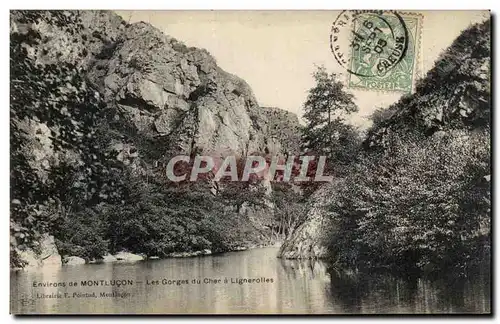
[365,20,491,149]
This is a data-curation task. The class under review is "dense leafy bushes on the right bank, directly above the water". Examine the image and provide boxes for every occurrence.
[331,131,490,273]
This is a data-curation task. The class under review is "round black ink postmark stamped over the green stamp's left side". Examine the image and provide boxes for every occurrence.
[330,10,408,77]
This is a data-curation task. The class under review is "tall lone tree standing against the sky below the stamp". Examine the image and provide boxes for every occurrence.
[302,66,358,165]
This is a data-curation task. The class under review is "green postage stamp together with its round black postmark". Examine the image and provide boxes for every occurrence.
[330,11,422,93]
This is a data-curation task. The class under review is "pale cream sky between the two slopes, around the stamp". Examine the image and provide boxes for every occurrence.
[117,11,489,128]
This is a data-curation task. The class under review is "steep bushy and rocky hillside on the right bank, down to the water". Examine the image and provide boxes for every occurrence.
[280,21,491,274]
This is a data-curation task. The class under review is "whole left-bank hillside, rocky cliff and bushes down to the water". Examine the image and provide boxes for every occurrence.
[10,11,299,265]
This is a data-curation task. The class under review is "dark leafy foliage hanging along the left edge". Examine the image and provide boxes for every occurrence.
[10,12,109,266]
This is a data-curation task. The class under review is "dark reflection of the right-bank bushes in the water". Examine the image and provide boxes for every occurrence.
[330,271,490,314]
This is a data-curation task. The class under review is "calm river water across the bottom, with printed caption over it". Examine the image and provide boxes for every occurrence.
[10,248,490,314]
